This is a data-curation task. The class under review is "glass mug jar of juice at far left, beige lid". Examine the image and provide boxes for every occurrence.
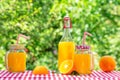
[5,44,26,72]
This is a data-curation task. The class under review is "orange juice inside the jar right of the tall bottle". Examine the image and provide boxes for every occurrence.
[74,53,92,74]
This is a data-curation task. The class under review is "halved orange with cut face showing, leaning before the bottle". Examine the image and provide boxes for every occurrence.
[59,60,73,74]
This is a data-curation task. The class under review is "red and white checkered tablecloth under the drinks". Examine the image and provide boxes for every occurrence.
[0,71,120,80]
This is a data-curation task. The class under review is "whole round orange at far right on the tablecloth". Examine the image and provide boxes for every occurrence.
[99,56,116,72]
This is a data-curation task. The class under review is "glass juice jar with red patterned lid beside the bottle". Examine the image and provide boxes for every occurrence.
[74,45,94,74]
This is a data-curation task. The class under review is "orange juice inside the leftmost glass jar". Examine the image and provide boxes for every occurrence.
[7,52,26,72]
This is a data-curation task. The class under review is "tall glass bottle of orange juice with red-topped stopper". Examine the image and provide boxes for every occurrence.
[58,17,75,68]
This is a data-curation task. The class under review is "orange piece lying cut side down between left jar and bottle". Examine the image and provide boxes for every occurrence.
[33,66,49,75]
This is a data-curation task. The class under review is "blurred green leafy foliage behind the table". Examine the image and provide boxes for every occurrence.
[0,0,120,70]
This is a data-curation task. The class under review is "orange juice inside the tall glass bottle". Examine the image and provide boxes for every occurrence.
[58,42,75,67]
